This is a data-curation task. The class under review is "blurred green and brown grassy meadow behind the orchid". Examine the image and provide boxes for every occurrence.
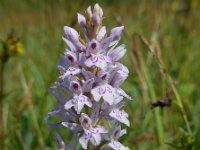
[0,0,200,150]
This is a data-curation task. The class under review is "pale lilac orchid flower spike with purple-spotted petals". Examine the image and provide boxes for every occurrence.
[46,4,131,150]
